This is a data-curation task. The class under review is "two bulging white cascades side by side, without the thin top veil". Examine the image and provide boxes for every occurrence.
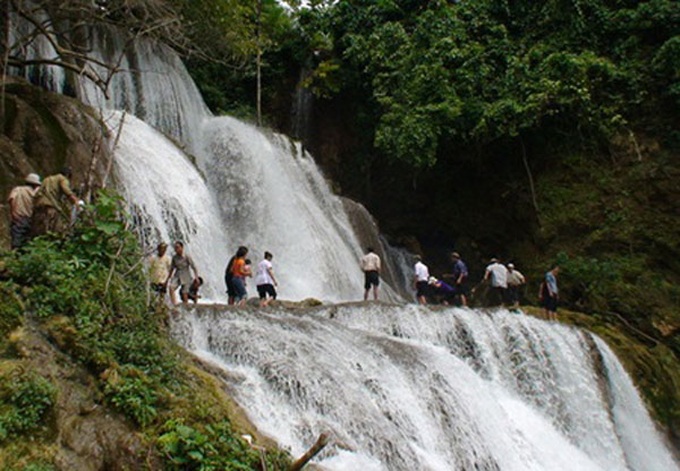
[109,106,396,301]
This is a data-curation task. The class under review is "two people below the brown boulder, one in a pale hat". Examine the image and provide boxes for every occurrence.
[7,167,84,249]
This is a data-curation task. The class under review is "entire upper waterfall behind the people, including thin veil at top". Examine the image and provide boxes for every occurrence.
[7,15,400,302]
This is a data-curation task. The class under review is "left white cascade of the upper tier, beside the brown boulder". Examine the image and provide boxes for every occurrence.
[106,112,229,299]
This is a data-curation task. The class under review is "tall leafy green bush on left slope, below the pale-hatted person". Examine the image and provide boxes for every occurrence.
[0,192,176,426]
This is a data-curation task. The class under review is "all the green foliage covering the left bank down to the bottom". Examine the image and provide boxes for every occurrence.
[0,192,287,469]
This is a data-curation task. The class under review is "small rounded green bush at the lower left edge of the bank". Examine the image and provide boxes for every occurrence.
[0,367,56,440]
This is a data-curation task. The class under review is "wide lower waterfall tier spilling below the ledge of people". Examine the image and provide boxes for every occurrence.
[173,304,678,471]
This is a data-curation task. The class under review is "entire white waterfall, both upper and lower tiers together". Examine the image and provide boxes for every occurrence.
[7,15,678,471]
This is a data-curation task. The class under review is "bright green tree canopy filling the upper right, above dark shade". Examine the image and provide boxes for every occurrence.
[286,0,680,166]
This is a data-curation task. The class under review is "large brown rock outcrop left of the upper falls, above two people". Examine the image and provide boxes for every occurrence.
[0,77,111,248]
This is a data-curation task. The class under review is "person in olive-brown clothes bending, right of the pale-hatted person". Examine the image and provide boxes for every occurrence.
[31,167,78,237]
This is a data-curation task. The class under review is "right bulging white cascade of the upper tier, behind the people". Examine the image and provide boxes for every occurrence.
[197,117,398,301]
